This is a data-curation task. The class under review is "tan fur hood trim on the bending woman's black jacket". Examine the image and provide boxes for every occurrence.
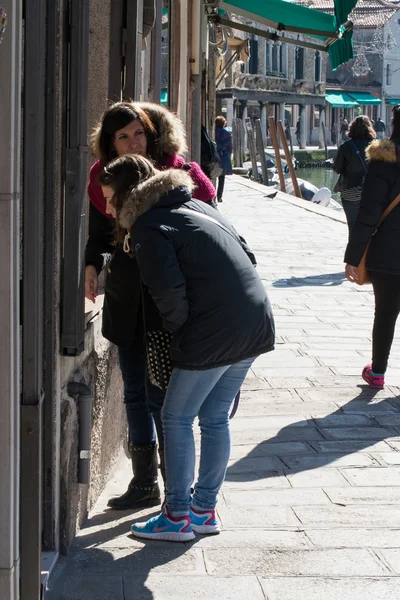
[118,169,194,231]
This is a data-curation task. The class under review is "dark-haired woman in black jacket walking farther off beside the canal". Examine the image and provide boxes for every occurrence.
[333,116,376,232]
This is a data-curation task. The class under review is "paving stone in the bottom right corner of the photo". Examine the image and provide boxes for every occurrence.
[261,577,400,600]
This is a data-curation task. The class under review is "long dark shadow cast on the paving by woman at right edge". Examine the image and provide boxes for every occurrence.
[225,386,399,482]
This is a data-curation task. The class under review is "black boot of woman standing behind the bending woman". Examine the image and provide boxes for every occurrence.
[108,444,161,510]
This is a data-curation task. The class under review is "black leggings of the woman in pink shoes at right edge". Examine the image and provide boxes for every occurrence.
[370,271,400,373]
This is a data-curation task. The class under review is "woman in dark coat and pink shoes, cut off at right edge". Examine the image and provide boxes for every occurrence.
[344,105,400,389]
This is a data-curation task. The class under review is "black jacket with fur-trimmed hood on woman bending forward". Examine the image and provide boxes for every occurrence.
[118,169,274,370]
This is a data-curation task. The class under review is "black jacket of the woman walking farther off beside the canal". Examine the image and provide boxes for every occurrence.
[333,140,370,192]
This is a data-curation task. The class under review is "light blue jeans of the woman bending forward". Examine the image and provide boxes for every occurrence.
[161,358,254,517]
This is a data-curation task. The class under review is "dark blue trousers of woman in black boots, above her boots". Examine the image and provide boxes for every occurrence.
[118,342,165,448]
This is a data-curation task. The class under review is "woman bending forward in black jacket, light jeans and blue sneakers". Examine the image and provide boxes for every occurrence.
[101,156,274,542]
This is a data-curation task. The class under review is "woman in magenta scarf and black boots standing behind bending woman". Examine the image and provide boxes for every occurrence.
[85,102,215,509]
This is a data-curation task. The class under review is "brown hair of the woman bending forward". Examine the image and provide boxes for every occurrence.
[99,154,157,242]
